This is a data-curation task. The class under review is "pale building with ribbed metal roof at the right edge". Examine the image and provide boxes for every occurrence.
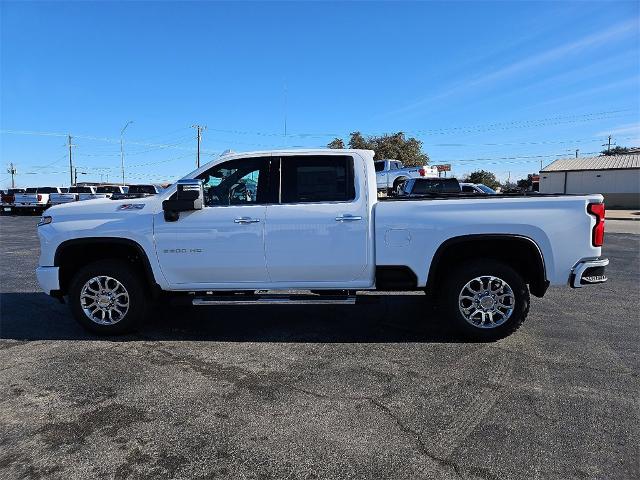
[540,153,640,209]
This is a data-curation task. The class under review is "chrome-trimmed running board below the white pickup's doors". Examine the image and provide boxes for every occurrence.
[191,294,356,306]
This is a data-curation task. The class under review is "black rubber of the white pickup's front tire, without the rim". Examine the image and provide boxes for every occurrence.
[68,259,150,335]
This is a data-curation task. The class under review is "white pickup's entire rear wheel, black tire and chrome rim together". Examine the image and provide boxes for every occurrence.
[445,260,530,340]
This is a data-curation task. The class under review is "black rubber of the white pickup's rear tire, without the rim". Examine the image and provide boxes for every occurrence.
[442,260,530,341]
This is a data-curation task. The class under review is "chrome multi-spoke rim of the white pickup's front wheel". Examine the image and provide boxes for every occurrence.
[80,275,129,325]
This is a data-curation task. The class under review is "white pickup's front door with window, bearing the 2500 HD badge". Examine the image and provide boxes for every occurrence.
[154,157,270,289]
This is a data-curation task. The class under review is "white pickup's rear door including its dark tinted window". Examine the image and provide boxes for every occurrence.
[265,155,372,288]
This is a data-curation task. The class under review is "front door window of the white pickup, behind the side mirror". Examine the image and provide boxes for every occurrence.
[198,157,270,207]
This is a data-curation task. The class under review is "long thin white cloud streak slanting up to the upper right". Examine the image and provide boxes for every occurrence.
[390,18,638,114]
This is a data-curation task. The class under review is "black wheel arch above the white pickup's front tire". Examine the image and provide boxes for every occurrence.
[53,237,161,296]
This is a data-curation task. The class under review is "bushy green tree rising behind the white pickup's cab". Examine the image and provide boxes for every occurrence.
[327,132,429,166]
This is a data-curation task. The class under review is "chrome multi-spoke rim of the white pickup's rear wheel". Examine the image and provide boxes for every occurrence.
[458,275,516,328]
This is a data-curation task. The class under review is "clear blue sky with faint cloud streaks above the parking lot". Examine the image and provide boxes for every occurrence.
[0,2,640,187]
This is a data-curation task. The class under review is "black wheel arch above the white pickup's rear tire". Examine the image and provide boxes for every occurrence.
[426,234,549,297]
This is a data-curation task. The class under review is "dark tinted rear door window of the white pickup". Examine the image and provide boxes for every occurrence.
[281,155,356,203]
